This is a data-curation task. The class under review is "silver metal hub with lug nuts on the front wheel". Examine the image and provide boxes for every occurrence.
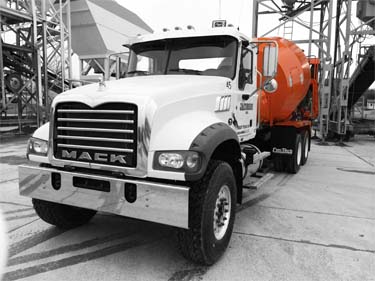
[214,185,232,240]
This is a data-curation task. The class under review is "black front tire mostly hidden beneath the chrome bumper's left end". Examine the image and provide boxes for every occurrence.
[32,198,96,229]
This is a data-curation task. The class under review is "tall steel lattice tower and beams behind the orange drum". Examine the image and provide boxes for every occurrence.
[253,0,375,142]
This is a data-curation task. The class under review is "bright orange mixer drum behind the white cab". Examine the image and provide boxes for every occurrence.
[258,37,311,126]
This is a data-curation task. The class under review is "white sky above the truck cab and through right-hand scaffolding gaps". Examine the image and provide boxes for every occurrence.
[116,0,375,88]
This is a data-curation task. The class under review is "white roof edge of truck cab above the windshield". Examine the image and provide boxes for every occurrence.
[124,27,250,46]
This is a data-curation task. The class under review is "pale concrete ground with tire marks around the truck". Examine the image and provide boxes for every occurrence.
[0,136,375,281]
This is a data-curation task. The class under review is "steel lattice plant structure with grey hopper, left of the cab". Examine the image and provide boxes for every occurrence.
[0,0,152,132]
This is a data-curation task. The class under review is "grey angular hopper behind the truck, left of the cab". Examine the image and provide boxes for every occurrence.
[71,0,152,80]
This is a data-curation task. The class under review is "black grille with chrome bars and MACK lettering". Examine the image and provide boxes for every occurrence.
[54,102,137,167]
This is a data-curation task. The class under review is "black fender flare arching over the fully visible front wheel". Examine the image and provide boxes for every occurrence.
[185,122,241,181]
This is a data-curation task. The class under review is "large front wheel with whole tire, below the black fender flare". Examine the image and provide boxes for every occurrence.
[177,160,237,265]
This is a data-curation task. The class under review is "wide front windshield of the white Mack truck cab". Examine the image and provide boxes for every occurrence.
[126,36,237,79]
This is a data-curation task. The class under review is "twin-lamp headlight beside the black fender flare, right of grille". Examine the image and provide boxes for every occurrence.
[153,151,201,173]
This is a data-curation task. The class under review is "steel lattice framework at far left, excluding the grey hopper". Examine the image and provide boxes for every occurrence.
[0,0,72,132]
